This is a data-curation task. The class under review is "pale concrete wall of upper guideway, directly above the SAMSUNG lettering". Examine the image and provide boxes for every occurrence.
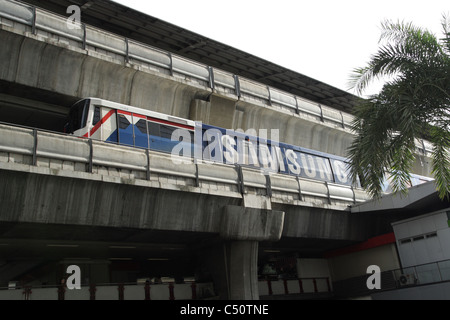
[190,95,353,156]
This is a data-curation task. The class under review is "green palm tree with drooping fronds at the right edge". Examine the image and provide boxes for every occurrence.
[349,16,450,199]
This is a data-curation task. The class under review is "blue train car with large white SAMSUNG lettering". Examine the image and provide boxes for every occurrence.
[202,124,352,185]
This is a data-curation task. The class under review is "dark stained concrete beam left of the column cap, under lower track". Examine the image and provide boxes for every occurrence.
[0,170,239,234]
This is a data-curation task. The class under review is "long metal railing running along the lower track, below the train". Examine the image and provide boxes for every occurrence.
[0,123,368,204]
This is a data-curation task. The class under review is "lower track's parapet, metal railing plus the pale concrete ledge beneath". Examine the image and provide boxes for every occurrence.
[0,125,368,215]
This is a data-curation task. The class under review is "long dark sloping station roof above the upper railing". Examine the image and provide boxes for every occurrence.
[22,0,358,113]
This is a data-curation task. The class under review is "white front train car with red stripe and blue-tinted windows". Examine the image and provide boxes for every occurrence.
[65,98,195,153]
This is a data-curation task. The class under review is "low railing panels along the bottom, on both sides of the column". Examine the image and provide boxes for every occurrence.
[0,277,332,301]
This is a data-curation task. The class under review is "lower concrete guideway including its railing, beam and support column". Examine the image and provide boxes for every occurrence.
[0,125,370,299]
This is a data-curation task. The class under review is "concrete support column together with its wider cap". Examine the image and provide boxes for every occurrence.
[197,205,284,300]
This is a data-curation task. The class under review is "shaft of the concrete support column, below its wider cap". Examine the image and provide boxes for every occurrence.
[225,241,259,300]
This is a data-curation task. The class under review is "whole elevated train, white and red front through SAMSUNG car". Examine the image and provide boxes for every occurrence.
[65,98,431,192]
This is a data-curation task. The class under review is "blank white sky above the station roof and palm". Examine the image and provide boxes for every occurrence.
[114,0,450,94]
